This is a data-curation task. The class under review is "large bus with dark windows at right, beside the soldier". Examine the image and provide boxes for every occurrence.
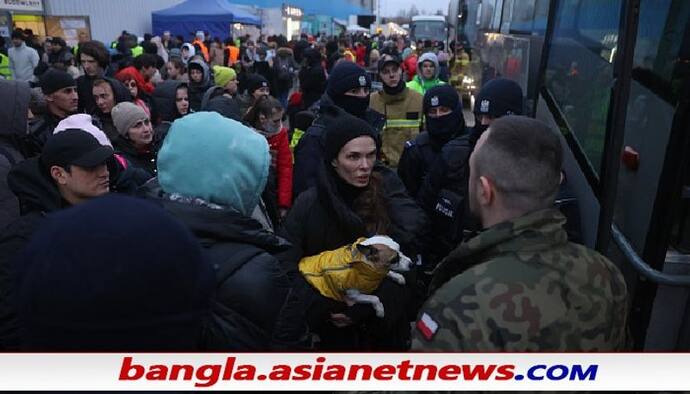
[448,0,690,351]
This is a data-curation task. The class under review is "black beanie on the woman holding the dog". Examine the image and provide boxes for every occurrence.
[324,107,378,163]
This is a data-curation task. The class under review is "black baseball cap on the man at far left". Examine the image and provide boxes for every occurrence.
[41,129,113,169]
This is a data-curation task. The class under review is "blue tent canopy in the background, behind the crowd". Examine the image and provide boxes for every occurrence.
[151,0,261,38]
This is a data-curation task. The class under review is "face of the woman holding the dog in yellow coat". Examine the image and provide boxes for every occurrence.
[331,136,376,187]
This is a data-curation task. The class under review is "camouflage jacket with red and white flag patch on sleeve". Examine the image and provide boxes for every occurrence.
[412,209,627,351]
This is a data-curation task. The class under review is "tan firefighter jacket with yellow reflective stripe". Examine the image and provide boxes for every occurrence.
[369,89,423,167]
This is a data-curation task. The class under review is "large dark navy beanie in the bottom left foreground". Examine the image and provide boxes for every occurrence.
[15,194,215,351]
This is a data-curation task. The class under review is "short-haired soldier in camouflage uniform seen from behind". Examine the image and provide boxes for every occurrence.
[412,116,627,351]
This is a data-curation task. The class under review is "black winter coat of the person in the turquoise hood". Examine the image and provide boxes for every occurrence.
[141,181,306,351]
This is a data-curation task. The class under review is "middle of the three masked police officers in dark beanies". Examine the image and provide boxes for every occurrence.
[398,85,465,198]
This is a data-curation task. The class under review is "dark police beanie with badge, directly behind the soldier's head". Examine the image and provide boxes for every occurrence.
[474,78,522,118]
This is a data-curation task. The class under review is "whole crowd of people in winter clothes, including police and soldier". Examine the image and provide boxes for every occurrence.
[0,30,628,351]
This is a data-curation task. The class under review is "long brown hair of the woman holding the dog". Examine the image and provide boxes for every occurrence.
[352,171,391,235]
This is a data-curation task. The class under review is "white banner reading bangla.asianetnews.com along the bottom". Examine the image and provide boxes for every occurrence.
[0,353,690,391]
